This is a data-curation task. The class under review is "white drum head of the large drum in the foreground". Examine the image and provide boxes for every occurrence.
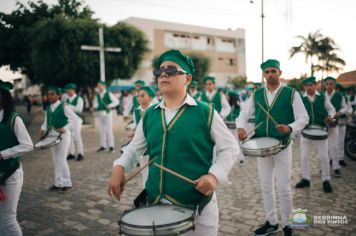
[120,205,194,227]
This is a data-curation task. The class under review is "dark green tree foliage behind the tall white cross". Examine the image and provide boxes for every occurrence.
[0,0,147,88]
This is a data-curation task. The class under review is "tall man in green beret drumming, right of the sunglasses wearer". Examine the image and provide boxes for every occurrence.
[236,59,309,236]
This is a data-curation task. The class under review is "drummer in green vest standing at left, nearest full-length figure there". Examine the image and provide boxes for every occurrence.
[40,86,78,193]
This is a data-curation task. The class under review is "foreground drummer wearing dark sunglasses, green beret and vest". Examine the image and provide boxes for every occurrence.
[108,50,239,236]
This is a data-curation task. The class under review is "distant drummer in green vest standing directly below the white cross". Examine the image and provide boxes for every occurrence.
[93,81,119,153]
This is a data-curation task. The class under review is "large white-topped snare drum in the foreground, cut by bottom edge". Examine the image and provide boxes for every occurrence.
[119,205,195,236]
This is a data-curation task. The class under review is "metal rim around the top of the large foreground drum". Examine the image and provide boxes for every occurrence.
[118,204,195,229]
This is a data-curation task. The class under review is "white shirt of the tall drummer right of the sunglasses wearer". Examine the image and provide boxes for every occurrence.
[236,84,309,133]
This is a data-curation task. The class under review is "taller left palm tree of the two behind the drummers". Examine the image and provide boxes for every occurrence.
[289,30,323,75]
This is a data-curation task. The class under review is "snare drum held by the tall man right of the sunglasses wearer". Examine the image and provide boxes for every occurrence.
[241,137,283,157]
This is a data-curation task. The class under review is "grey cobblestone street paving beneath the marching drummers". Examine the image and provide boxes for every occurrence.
[18,106,356,236]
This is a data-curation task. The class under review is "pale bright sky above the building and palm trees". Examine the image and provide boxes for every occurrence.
[0,0,356,81]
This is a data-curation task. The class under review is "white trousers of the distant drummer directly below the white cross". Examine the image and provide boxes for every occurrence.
[99,112,114,148]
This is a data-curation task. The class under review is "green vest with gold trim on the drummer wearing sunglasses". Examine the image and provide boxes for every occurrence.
[143,101,214,209]
